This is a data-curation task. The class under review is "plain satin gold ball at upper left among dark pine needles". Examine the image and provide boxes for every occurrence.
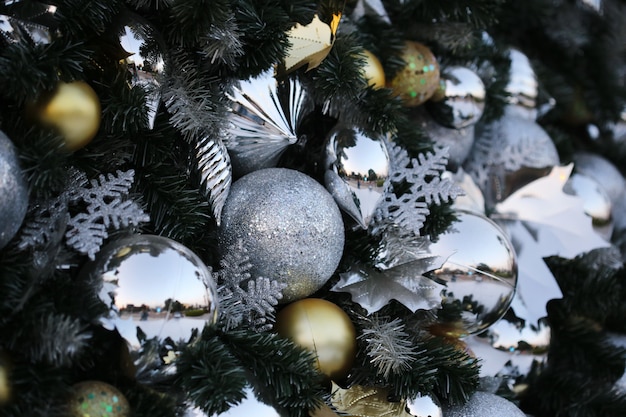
[35,81,101,151]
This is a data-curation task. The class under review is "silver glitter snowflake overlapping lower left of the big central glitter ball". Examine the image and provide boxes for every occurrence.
[217,241,287,331]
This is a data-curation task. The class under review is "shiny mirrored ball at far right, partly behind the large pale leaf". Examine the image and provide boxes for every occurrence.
[563,173,613,241]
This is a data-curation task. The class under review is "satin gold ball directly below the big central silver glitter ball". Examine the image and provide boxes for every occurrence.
[275,298,356,380]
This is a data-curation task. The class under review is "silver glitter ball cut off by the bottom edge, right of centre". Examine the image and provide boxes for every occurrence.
[443,391,526,417]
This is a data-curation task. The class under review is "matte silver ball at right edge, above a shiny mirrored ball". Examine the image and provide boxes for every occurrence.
[574,152,626,205]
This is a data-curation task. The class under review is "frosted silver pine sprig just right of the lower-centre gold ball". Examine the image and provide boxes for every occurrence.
[359,315,417,378]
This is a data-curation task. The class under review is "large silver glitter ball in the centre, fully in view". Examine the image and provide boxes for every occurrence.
[218,168,345,303]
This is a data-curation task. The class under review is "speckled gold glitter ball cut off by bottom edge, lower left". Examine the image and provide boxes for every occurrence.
[68,381,130,417]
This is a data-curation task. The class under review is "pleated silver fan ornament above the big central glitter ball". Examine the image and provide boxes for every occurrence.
[224,69,312,177]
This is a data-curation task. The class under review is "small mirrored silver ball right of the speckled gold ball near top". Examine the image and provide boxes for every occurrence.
[426,66,485,129]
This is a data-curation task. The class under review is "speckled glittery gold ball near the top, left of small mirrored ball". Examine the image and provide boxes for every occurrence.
[389,41,440,107]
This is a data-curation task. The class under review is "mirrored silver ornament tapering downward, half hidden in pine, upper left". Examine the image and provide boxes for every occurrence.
[119,16,165,129]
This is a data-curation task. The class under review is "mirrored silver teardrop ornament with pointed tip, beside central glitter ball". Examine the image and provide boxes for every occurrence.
[324,129,389,229]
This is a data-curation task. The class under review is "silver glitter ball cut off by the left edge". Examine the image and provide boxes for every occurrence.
[0,131,28,249]
